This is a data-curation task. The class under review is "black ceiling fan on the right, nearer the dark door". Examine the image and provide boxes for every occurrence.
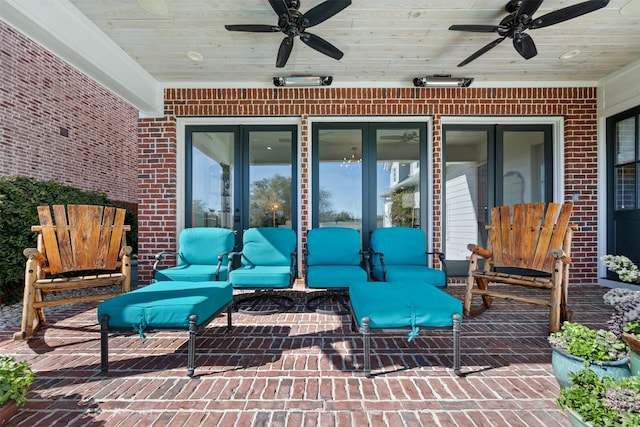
[449,0,609,67]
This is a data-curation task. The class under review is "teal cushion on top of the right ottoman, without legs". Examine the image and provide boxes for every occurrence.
[349,281,462,329]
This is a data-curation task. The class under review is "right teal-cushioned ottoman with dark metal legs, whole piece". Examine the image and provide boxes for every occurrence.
[349,281,462,377]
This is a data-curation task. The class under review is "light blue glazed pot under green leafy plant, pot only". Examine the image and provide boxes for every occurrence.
[551,346,631,387]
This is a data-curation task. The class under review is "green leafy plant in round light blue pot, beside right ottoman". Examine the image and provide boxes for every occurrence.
[548,322,631,387]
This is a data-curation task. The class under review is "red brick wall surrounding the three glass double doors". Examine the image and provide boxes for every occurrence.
[138,88,598,284]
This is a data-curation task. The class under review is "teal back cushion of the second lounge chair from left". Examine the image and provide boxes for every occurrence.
[242,227,296,266]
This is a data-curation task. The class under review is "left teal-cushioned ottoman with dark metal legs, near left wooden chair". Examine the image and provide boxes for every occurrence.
[98,281,233,377]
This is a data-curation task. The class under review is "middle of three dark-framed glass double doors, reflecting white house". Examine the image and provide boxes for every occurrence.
[312,123,426,247]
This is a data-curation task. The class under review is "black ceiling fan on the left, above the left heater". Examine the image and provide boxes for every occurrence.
[224,0,351,68]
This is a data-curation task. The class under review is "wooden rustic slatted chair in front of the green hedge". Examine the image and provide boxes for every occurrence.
[14,205,131,339]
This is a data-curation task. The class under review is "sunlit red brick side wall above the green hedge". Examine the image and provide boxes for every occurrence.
[0,22,138,203]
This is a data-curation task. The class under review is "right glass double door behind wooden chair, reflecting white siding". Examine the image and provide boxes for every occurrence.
[443,125,553,275]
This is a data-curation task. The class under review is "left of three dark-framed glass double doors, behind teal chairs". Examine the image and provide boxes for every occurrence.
[185,125,297,244]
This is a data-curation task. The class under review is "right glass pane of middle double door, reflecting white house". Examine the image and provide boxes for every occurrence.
[376,128,420,228]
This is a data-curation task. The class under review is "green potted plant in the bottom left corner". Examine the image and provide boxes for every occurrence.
[0,355,34,425]
